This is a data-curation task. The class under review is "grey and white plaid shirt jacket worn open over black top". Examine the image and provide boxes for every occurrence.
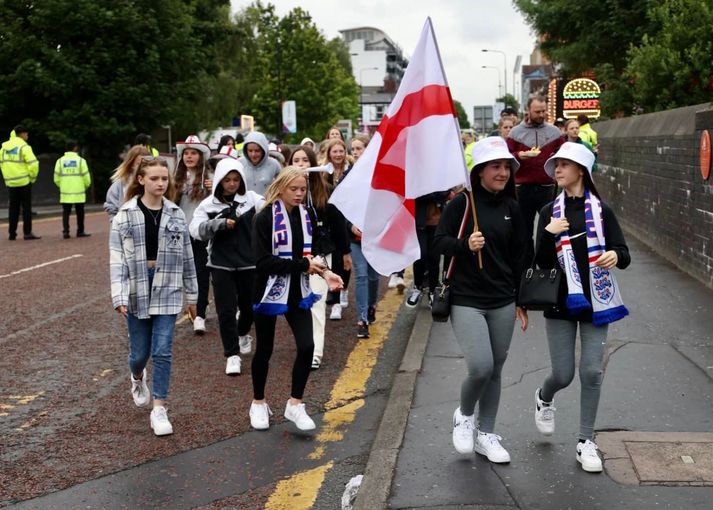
[109,197,198,319]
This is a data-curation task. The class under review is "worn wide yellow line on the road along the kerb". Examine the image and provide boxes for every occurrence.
[265,272,411,510]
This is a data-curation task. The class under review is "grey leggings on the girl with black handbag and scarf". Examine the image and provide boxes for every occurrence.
[541,319,609,439]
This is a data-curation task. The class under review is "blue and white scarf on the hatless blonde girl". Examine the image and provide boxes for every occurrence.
[253,199,321,315]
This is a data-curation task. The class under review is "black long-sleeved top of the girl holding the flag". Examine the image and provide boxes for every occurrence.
[434,186,527,309]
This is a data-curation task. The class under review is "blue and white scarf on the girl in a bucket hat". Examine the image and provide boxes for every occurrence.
[552,189,629,326]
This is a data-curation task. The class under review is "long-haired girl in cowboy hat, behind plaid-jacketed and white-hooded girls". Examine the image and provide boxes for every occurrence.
[172,135,213,335]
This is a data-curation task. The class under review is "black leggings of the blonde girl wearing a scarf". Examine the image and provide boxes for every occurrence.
[253,307,314,400]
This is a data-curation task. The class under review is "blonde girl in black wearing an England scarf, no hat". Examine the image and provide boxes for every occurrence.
[250,167,342,430]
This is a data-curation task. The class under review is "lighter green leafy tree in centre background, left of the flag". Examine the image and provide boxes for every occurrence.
[237,1,359,140]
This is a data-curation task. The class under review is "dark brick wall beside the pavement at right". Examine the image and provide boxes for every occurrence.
[594,103,713,288]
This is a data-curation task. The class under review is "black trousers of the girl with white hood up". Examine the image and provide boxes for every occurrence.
[210,268,255,358]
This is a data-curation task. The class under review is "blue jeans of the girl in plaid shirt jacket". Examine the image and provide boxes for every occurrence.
[126,269,177,400]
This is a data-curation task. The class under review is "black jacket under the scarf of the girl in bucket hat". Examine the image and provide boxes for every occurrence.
[535,197,631,322]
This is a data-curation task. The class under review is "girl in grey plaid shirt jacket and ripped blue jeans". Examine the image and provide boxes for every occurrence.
[109,156,198,436]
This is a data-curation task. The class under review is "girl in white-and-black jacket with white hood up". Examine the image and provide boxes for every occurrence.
[189,157,263,375]
